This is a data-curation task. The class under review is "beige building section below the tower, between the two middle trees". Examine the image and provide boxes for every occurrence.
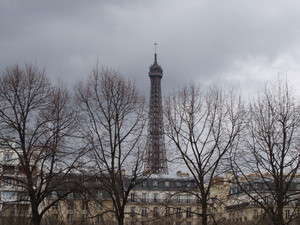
[126,171,200,225]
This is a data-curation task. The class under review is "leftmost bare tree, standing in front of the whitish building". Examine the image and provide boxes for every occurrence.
[0,64,83,225]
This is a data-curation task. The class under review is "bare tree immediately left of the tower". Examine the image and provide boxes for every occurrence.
[77,66,147,224]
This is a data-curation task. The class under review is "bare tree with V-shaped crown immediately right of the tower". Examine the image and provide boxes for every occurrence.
[165,84,244,225]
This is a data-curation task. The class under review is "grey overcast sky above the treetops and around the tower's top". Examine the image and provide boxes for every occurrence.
[0,0,300,94]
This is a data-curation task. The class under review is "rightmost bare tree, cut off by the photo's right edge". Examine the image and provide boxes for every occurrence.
[231,81,300,225]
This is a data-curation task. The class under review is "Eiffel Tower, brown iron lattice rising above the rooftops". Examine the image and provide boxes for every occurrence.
[146,53,168,174]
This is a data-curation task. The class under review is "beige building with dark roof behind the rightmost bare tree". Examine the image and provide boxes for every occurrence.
[224,173,300,224]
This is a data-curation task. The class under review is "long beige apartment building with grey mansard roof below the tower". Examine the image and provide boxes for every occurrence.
[47,172,200,225]
